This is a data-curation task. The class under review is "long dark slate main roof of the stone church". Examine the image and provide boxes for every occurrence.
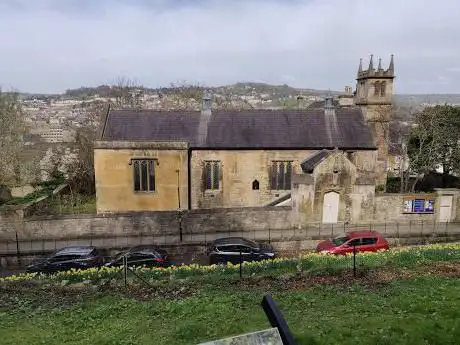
[101,108,375,149]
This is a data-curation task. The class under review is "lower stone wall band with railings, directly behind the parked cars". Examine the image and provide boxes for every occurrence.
[0,223,460,273]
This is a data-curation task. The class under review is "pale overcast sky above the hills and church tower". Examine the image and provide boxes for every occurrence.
[0,0,460,93]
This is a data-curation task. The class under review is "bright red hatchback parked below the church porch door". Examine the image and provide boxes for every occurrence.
[316,230,390,255]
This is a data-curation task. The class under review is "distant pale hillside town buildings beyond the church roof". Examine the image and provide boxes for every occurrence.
[22,84,323,143]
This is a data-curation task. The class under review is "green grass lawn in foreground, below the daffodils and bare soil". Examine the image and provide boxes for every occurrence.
[0,272,460,345]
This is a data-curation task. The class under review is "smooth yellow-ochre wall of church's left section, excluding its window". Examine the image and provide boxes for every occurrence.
[94,142,187,213]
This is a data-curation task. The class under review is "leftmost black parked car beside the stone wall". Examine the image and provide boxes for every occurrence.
[26,246,104,274]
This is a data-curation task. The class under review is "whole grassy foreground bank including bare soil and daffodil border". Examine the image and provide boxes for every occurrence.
[0,245,460,345]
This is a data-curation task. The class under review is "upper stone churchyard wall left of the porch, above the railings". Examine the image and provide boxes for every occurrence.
[0,207,293,241]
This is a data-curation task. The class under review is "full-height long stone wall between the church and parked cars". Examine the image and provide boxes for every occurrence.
[0,201,460,265]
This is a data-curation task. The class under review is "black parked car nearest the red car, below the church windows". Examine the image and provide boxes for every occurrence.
[208,237,275,264]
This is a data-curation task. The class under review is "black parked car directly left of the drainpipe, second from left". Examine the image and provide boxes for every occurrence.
[105,245,170,267]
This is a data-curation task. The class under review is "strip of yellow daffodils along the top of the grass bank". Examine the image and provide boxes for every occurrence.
[0,244,460,283]
